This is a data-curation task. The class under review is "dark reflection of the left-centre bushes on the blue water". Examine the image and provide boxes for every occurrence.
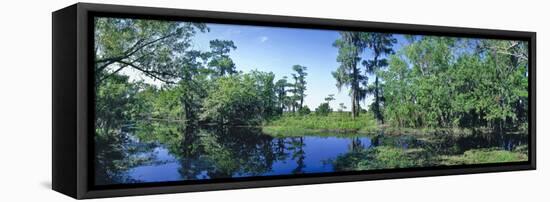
[136,122,286,179]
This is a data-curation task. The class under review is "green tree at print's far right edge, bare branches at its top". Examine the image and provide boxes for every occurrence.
[479,40,529,131]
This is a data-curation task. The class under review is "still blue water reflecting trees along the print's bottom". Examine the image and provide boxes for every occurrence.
[95,124,526,185]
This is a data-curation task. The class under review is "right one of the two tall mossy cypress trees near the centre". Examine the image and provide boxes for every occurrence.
[361,32,397,123]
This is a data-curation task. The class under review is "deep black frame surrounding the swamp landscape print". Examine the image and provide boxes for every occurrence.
[52,3,536,199]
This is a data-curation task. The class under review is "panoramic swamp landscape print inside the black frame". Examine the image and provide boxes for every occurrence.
[92,17,529,185]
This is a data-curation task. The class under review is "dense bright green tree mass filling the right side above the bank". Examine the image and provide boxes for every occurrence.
[379,37,527,130]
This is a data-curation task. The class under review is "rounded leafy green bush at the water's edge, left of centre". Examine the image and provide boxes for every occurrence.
[200,71,277,126]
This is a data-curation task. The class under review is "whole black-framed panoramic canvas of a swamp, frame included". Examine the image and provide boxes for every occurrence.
[52,3,536,199]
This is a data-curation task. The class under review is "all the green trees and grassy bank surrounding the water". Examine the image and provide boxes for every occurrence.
[94,18,529,185]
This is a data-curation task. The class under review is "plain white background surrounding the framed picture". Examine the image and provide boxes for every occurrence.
[0,0,550,202]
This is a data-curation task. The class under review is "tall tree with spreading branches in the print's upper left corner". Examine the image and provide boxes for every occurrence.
[94,18,208,129]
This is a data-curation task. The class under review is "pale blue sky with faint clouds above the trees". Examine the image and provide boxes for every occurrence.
[193,24,410,110]
